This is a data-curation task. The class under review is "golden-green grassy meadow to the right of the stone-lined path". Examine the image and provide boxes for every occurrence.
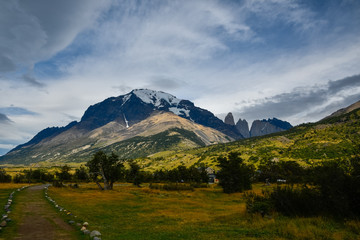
[49,184,360,240]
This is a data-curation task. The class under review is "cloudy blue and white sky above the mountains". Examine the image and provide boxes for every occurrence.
[0,0,360,155]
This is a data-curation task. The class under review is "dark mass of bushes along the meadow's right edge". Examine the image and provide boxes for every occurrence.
[246,158,360,218]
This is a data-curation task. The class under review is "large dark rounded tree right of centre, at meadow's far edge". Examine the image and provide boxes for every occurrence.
[217,152,254,193]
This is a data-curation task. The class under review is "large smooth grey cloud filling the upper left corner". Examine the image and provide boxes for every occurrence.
[0,0,108,74]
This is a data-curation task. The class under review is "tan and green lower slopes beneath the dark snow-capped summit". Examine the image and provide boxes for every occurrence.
[1,112,232,165]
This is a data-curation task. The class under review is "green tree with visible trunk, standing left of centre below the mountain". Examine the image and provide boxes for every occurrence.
[86,151,124,190]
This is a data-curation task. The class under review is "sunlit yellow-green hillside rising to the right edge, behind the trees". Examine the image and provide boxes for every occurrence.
[137,110,360,171]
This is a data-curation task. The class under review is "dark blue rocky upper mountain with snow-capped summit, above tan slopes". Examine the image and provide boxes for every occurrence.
[78,89,242,139]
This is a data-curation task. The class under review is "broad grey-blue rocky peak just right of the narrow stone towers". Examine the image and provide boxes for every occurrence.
[250,118,292,137]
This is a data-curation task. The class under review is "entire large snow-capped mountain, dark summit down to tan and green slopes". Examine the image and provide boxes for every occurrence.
[0,89,236,164]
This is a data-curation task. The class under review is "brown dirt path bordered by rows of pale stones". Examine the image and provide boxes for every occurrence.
[13,185,78,240]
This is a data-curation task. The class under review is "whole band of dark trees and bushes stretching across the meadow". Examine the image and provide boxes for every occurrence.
[0,151,360,217]
